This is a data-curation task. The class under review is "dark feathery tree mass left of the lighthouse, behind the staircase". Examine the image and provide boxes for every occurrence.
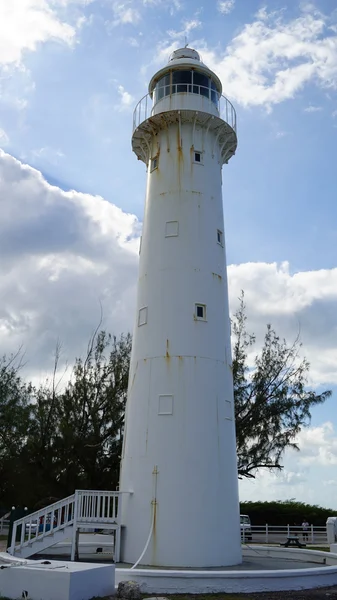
[8,328,131,508]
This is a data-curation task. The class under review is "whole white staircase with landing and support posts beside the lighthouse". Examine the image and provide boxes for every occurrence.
[8,490,121,562]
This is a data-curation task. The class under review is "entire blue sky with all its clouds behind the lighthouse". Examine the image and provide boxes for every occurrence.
[0,0,337,510]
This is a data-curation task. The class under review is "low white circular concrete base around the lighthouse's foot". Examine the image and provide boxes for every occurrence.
[116,546,337,595]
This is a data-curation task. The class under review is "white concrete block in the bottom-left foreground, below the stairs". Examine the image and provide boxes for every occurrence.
[0,560,115,600]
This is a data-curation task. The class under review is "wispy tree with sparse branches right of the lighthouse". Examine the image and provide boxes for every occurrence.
[232,293,331,477]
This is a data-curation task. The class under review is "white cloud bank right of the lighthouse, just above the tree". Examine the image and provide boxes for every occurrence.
[228,262,337,385]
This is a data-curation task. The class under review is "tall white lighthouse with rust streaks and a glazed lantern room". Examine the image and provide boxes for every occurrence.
[120,48,242,569]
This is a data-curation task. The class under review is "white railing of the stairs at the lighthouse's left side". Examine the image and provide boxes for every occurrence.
[8,490,122,557]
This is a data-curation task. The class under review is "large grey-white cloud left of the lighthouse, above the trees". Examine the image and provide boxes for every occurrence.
[0,152,139,376]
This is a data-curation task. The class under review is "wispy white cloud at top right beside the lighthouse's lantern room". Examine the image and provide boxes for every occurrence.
[196,9,337,109]
